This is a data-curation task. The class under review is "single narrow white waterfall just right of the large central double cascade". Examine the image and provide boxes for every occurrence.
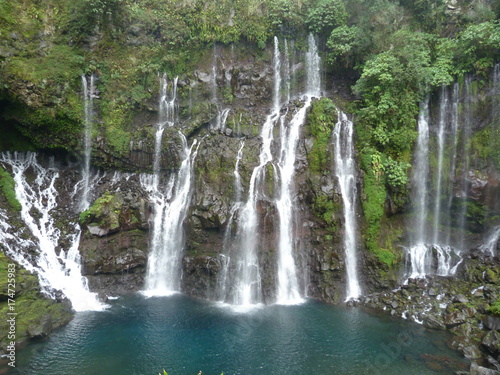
[333,111,361,301]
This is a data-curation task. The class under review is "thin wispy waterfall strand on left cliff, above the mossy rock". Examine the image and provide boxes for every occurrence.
[79,74,95,211]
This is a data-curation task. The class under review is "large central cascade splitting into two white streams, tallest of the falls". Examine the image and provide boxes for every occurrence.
[217,36,321,307]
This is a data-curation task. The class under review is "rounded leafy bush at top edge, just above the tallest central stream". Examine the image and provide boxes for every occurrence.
[306,0,347,35]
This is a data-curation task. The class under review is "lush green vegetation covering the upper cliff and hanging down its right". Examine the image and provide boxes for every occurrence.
[0,0,500,264]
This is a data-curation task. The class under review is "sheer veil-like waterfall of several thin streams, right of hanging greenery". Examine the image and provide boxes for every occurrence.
[407,77,482,277]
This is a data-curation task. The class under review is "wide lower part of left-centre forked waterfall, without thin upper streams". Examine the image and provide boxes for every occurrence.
[141,132,199,297]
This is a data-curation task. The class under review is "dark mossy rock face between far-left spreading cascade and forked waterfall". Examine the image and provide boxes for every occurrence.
[80,175,151,296]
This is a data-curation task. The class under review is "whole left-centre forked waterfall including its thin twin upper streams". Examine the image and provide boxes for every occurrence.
[141,74,198,296]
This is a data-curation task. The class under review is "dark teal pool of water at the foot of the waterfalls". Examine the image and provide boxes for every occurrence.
[9,295,464,375]
